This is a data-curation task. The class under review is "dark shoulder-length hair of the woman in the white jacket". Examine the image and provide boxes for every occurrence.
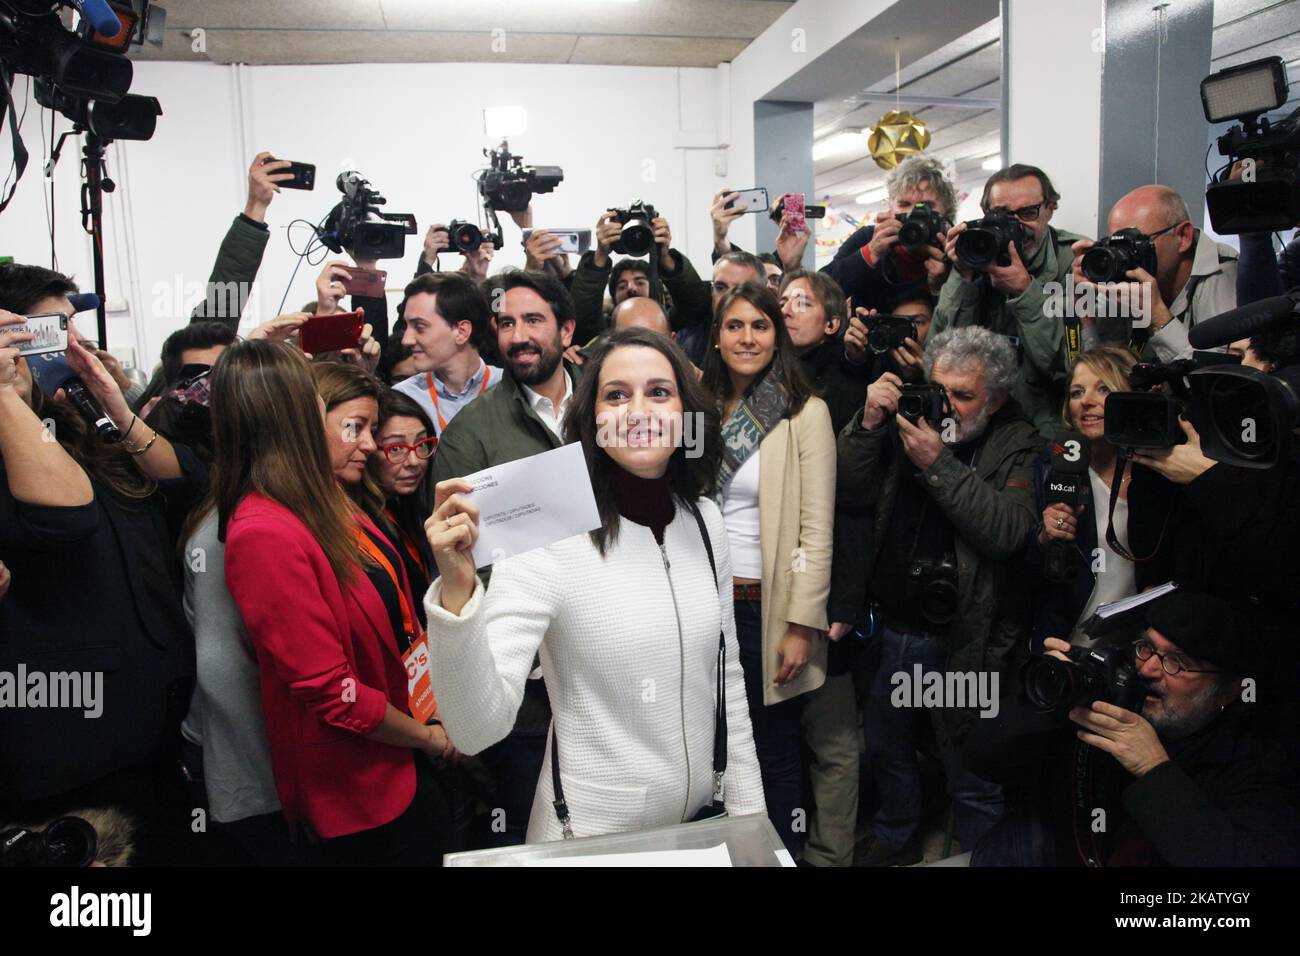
[564,328,723,555]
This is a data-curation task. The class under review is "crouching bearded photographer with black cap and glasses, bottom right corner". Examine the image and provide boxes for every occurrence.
[963,591,1300,866]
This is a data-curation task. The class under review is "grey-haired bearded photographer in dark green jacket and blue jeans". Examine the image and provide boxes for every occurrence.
[829,328,1041,866]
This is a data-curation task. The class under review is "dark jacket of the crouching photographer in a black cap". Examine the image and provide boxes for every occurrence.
[962,695,1300,866]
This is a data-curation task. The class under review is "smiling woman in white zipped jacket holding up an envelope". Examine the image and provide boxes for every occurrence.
[425,329,764,843]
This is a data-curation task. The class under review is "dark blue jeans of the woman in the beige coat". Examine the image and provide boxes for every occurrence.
[736,601,807,853]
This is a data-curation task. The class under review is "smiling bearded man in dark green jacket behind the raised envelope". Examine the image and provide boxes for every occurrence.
[433,269,579,845]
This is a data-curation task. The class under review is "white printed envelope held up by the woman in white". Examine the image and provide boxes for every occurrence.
[465,442,601,567]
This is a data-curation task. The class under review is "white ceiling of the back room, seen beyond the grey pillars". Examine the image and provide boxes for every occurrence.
[814,0,1300,216]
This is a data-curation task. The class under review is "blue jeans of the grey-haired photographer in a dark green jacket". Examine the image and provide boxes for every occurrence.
[863,627,1002,849]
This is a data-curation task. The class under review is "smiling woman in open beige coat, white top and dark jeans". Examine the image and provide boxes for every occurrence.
[703,284,836,852]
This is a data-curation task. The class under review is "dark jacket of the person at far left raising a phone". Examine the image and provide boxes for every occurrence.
[0,445,208,800]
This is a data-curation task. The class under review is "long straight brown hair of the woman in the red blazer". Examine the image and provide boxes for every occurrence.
[209,338,360,583]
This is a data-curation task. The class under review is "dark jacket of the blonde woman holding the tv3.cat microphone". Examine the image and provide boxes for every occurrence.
[1024,447,1186,653]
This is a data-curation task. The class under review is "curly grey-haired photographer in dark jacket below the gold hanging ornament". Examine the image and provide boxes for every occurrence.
[822,155,957,310]
